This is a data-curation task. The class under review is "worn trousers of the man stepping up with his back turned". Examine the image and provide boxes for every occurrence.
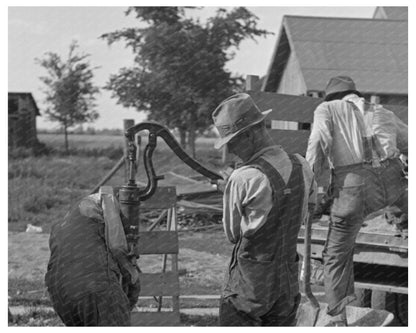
[323,159,408,315]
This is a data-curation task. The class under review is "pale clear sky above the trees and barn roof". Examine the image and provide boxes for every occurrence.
[8,6,375,129]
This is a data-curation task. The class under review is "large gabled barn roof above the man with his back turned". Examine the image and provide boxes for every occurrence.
[262,16,408,94]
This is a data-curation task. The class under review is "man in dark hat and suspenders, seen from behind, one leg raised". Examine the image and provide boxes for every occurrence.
[306,76,408,326]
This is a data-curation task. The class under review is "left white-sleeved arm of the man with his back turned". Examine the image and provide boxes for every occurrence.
[306,103,333,178]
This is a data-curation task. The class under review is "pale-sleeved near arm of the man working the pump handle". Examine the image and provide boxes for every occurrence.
[223,167,272,243]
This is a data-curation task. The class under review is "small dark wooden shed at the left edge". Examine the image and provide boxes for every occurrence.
[8,92,40,148]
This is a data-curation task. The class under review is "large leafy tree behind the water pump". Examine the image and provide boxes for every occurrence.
[101,7,269,157]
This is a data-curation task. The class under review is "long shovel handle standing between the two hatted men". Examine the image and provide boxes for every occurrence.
[303,204,319,309]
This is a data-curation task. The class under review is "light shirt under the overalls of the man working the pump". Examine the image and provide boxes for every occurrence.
[223,146,316,243]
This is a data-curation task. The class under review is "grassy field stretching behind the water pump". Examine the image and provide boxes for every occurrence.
[8,134,221,231]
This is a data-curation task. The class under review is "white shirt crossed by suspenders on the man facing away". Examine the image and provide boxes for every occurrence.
[306,94,408,177]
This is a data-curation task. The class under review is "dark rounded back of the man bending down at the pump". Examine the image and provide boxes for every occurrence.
[45,199,118,298]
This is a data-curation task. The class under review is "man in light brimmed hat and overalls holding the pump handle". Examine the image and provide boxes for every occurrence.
[212,93,316,326]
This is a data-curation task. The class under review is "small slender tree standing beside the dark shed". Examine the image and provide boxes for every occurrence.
[35,41,99,153]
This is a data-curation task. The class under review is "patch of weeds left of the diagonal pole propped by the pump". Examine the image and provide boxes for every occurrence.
[8,156,123,231]
